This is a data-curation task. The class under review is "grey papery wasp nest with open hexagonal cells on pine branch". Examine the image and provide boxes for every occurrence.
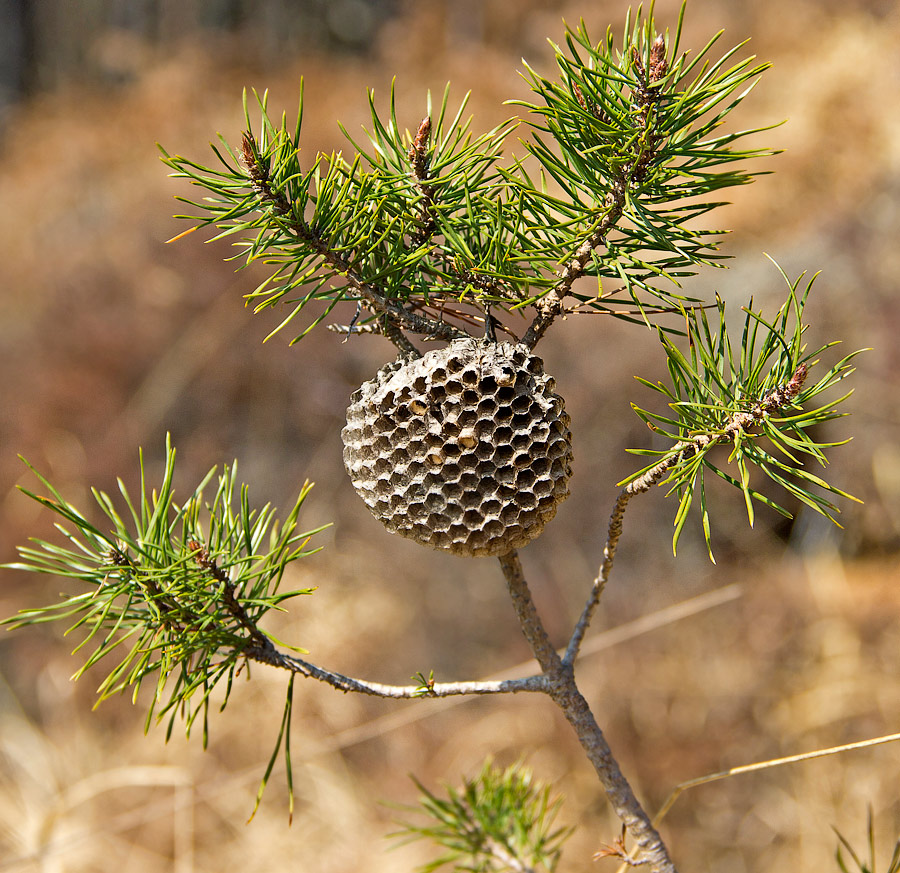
[341,339,572,557]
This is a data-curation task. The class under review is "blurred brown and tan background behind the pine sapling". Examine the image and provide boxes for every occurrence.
[0,0,900,873]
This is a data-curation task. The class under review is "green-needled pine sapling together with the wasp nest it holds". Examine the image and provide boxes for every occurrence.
[7,7,868,873]
